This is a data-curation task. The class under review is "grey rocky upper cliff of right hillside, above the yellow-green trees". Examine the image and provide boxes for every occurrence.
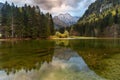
[83,0,120,17]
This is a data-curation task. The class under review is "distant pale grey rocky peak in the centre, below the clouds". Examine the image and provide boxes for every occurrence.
[53,13,79,28]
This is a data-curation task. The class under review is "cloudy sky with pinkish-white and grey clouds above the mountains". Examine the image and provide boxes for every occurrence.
[0,0,95,16]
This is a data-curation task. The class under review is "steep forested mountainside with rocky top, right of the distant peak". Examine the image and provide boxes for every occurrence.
[74,0,120,37]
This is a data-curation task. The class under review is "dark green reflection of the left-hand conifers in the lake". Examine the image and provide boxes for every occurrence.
[0,41,54,74]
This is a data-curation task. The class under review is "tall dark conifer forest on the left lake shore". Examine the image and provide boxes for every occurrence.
[1,2,54,38]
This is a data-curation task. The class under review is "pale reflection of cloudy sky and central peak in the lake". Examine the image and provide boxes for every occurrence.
[0,47,103,80]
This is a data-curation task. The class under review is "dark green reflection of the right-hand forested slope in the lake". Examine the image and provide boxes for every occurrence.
[70,40,120,80]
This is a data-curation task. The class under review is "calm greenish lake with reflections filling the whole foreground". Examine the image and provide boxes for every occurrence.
[0,39,120,80]
